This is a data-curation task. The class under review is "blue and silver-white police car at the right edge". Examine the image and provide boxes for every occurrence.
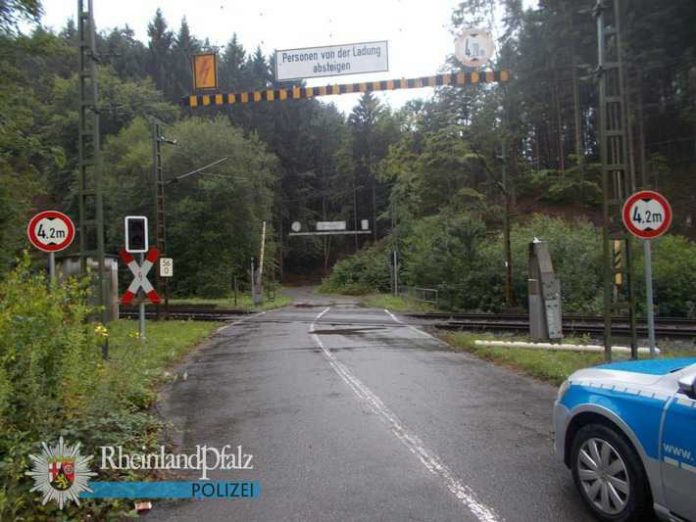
[554,358,696,522]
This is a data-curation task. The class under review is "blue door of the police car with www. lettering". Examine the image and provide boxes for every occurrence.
[660,372,696,521]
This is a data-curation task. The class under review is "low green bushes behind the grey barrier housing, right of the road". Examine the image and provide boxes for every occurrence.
[396,213,601,313]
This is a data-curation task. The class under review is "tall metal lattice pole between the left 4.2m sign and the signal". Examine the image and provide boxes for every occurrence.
[77,0,109,358]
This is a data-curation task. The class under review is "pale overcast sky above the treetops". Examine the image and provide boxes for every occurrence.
[38,0,524,112]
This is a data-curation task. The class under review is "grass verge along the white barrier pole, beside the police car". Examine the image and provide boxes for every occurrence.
[439,332,696,385]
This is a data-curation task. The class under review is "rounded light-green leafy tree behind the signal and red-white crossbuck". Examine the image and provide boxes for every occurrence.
[104,117,278,296]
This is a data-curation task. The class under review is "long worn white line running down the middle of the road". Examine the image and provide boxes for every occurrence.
[309,307,502,522]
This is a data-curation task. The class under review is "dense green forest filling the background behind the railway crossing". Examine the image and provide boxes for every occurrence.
[0,0,696,315]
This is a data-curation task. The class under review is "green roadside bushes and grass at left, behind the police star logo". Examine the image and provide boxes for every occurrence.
[0,257,217,521]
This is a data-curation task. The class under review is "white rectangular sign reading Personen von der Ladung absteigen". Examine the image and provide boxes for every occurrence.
[275,40,389,81]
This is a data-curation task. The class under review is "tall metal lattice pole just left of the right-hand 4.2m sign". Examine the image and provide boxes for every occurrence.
[594,0,638,361]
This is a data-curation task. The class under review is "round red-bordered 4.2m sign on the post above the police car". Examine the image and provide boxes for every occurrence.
[622,190,672,239]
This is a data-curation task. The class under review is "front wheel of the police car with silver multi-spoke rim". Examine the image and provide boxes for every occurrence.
[571,424,652,522]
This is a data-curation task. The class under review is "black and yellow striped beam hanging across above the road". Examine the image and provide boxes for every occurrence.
[183,70,510,108]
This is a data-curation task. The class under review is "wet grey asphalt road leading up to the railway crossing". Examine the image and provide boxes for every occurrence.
[147,298,590,522]
